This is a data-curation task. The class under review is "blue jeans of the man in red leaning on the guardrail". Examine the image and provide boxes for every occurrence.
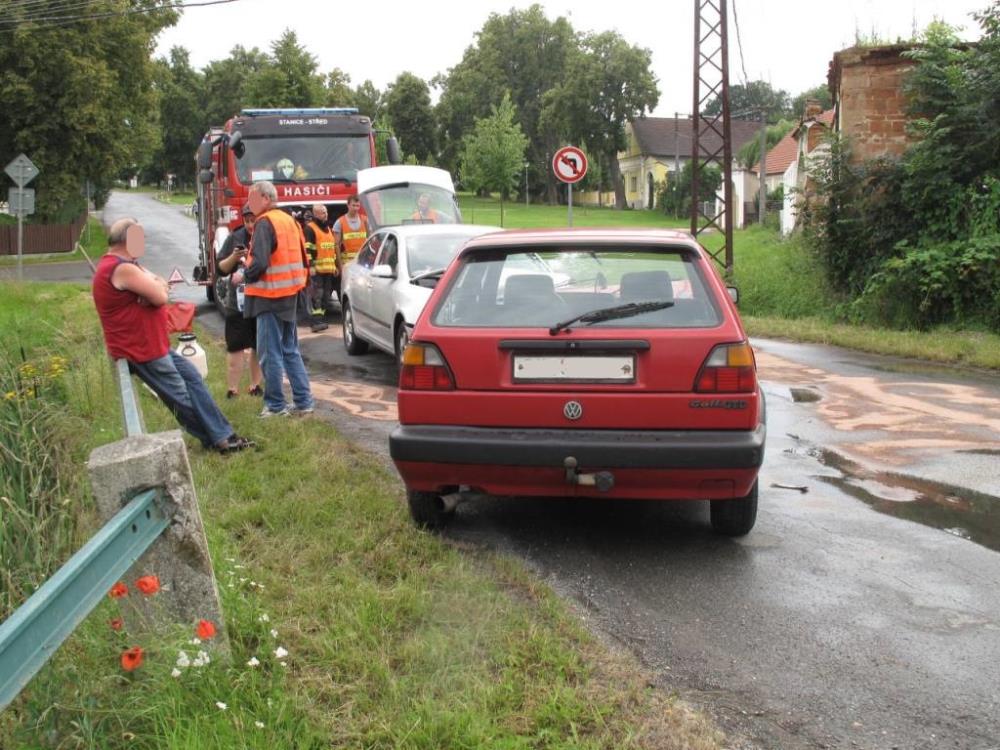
[129,351,234,448]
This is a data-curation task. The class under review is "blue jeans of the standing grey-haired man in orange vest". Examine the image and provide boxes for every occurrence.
[257,312,314,411]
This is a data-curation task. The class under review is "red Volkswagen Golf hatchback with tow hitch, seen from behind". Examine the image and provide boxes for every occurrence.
[390,229,766,536]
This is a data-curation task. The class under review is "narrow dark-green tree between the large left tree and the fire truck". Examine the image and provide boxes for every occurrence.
[151,47,211,188]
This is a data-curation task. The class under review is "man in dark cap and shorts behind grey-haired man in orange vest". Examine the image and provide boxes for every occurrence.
[215,203,264,398]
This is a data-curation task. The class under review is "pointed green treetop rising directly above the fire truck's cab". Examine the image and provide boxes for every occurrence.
[244,29,325,107]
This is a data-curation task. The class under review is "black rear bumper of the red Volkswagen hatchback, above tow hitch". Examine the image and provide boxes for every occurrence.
[389,424,767,470]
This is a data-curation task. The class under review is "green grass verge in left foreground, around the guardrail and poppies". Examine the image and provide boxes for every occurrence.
[0,284,719,750]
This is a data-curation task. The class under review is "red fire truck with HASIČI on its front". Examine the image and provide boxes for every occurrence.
[193,107,400,310]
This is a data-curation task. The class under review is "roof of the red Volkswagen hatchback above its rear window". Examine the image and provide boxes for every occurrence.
[462,227,698,255]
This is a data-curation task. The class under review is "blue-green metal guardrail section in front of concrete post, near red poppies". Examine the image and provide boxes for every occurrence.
[0,489,170,710]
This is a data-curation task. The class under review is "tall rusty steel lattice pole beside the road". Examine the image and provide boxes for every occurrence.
[691,0,733,276]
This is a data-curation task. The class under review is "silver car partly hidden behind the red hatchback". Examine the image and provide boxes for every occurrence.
[340,224,503,359]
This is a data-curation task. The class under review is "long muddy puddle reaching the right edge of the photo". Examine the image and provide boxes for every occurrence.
[815,449,1000,552]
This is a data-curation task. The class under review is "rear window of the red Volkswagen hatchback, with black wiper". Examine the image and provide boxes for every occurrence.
[431,246,722,328]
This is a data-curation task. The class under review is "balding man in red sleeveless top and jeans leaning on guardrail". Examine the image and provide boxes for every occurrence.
[92,219,254,453]
